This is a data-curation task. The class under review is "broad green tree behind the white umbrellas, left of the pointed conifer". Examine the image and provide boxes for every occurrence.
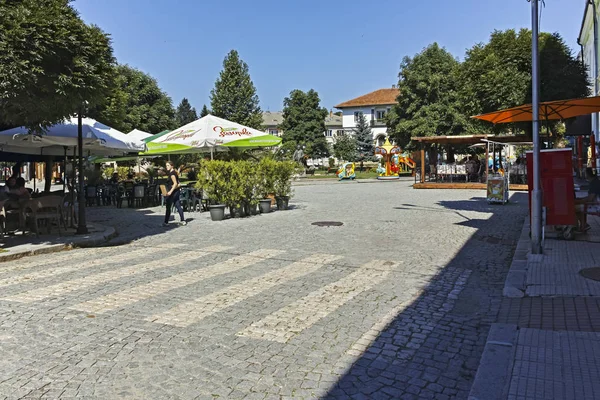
[89,65,176,133]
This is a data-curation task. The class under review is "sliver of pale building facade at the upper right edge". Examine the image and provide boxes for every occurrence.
[577,0,600,143]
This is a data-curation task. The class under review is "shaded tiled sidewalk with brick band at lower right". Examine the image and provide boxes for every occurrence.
[469,217,600,400]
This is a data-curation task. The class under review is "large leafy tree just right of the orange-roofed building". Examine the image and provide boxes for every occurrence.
[387,43,465,148]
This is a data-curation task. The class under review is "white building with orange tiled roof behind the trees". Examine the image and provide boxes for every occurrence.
[335,87,400,144]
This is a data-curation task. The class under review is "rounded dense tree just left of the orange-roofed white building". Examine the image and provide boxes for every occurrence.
[279,89,330,158]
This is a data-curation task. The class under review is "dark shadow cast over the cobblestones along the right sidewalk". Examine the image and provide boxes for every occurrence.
[325,193,527,399]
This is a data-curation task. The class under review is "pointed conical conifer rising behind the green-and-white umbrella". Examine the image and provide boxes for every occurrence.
[210,50,262,129]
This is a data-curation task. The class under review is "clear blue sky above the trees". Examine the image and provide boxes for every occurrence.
[73,0,585,118]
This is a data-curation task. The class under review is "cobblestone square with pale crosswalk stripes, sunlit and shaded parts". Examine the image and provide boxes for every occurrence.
[0,181,527,399]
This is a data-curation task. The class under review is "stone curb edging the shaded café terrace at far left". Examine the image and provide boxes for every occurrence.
[0,224,118,263]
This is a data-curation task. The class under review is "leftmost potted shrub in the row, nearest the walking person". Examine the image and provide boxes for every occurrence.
[196,160,231,221]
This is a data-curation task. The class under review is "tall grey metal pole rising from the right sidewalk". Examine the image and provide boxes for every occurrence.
[531,0,542,254]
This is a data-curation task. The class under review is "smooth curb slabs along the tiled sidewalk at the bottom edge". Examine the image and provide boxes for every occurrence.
[468,324,518,400]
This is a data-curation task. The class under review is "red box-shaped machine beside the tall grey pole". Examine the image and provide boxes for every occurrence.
[527,149,577,226]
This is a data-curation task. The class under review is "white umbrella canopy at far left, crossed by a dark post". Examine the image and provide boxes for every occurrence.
[0,117,144,155]
